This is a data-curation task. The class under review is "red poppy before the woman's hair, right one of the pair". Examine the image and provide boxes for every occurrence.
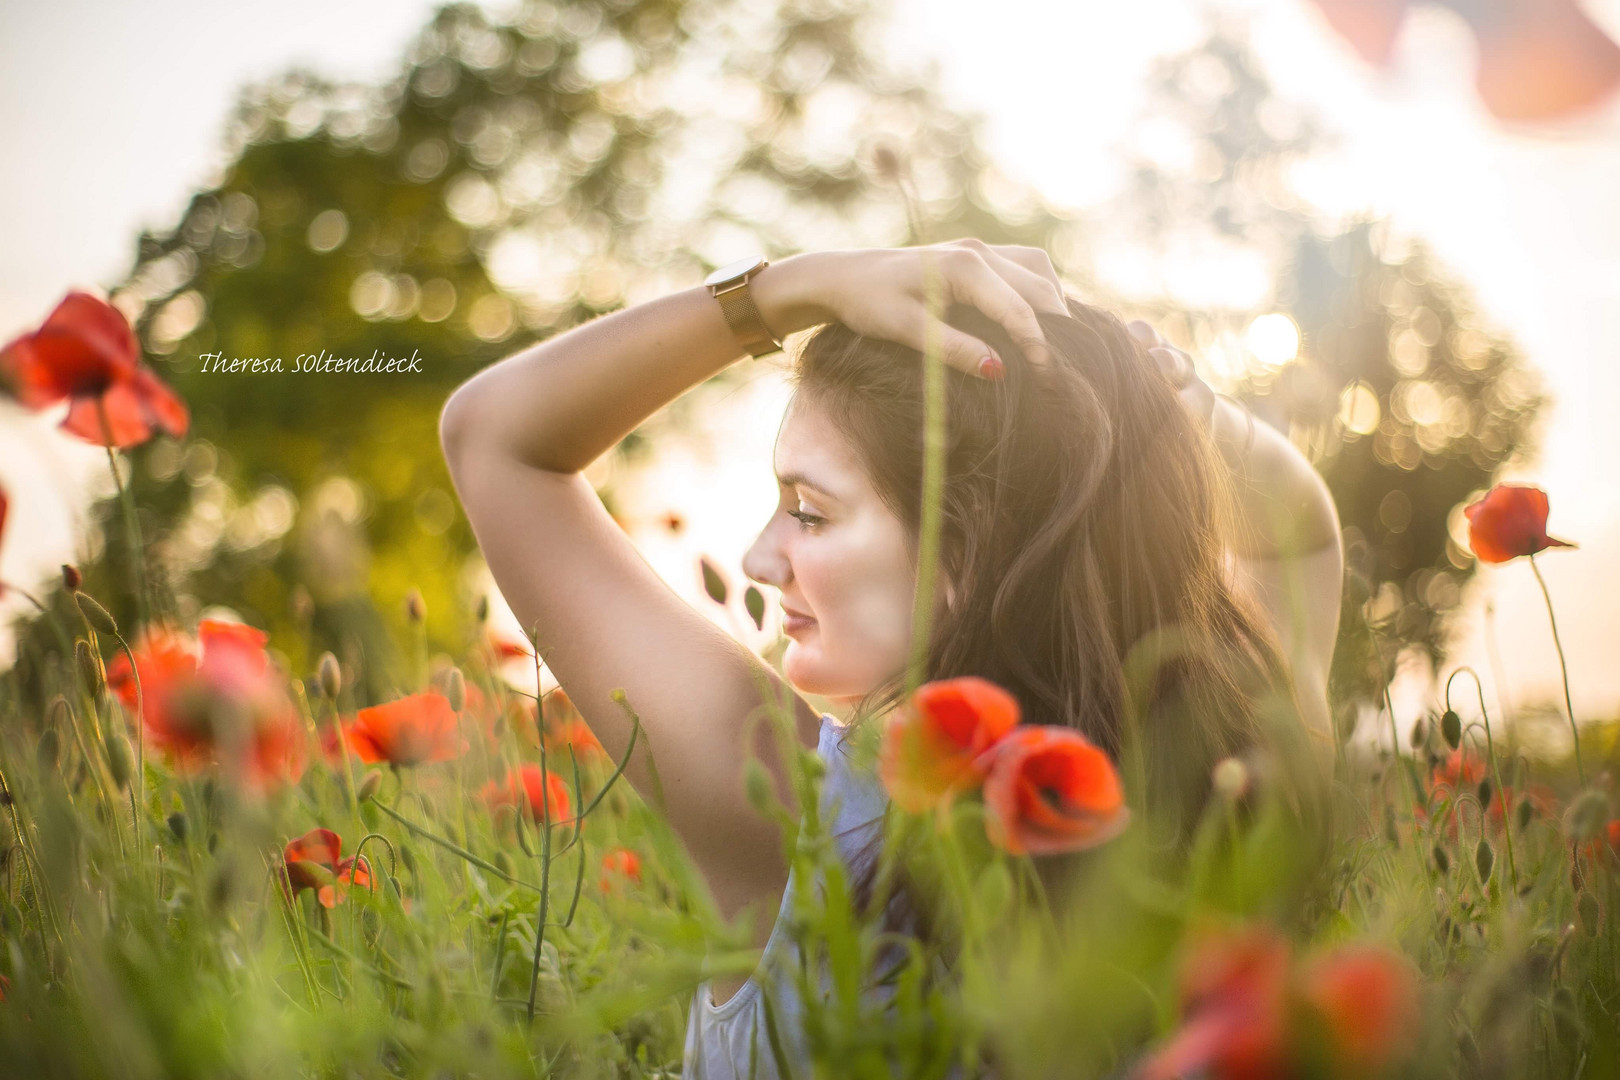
[985,725,1131,855]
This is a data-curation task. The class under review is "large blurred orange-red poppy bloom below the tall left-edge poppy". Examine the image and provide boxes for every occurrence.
[107,619,305,789]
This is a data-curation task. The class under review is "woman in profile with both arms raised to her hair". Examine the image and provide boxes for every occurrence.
[441,240,1341,1075]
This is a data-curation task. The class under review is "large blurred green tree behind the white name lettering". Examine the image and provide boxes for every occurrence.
[15,0,1063,709]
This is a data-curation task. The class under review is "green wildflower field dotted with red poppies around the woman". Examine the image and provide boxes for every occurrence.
[0,295,1620,1078]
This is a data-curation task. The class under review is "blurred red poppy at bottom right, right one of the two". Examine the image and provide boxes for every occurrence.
[1301,946,1419,1077]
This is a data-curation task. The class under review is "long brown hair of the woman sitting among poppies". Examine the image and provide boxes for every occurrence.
[792,289,1315,936]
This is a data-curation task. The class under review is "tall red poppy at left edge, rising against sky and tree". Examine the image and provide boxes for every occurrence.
[0,291,191,447]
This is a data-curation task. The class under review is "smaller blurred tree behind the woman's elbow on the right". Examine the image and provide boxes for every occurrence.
[1092,24,1545,719]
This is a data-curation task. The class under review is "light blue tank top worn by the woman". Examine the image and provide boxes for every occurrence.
[680,714,894,1080]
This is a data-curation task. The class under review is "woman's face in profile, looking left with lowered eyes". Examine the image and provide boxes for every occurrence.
[742,397,917,704]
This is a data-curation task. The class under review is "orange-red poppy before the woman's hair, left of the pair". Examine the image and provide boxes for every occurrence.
[878,675,1019,813]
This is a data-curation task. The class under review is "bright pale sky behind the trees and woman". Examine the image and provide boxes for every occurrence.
[0,0,1620,735]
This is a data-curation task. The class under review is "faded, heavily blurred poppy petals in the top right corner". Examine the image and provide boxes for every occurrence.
[1315,0,1620,120]
